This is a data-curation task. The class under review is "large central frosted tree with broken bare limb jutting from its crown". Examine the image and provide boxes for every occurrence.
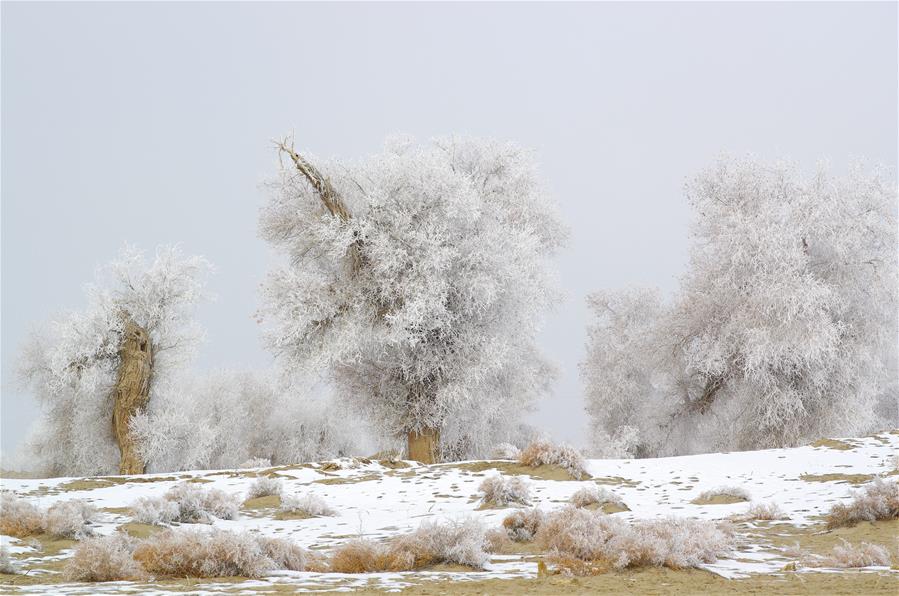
[261,138,565,461]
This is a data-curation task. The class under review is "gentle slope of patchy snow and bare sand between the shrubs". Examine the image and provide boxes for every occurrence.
[0,431,899,594]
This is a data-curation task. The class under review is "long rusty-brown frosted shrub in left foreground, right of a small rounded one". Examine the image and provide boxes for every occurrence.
[134,529,305,577]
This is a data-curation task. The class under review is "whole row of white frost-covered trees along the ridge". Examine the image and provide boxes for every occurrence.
[15,138,897,474]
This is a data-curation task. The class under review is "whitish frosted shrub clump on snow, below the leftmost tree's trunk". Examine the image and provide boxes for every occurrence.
[131,482,240,525]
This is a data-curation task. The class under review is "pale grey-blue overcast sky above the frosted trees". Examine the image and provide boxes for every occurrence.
[0,2,899,451]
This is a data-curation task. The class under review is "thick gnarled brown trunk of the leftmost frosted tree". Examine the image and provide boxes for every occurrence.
[112,315,153,474]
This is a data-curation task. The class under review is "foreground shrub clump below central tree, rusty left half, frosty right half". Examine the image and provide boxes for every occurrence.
[330,519,488,573]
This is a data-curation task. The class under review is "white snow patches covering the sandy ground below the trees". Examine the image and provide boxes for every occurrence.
[0,431,899,593]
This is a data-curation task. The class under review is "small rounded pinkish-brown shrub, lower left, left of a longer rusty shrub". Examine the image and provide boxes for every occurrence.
[63,533,147,582]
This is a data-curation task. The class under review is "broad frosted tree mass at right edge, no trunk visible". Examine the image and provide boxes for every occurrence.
[582,159,897,454]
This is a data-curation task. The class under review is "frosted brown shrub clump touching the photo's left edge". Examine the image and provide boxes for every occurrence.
[0,492,97,540]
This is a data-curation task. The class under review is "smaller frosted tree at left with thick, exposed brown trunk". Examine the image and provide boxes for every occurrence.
[20,247,208,475]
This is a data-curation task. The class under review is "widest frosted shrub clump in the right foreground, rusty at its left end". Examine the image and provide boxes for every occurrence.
[537,506,732,573]
